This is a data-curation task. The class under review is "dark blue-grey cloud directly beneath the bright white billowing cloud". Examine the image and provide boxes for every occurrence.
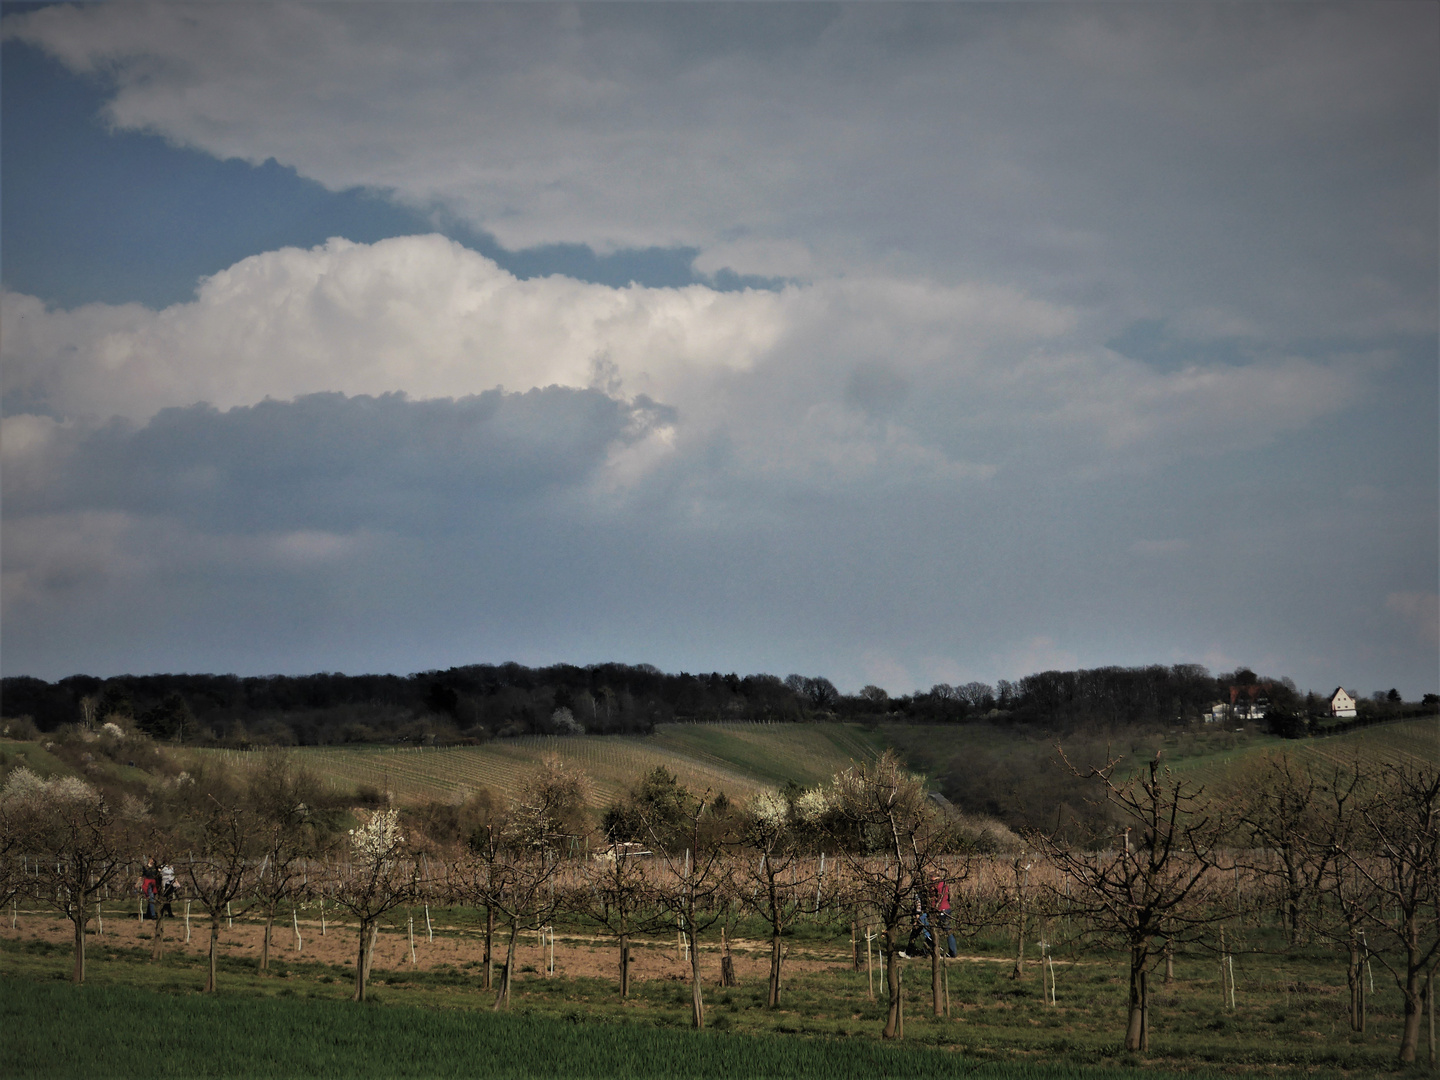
[6,386,674,533]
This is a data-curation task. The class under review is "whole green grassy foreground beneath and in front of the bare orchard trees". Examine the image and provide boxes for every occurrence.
[0,910,1424,1080]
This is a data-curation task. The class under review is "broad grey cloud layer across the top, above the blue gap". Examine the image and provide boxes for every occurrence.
[7,4,1440,340]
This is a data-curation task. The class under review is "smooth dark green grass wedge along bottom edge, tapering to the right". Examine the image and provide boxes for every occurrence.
[0,978,1195,1080]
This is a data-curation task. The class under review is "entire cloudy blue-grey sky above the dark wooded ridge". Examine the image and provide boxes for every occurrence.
[0,3,1440,698]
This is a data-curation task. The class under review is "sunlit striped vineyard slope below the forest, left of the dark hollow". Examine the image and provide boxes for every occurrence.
[193,723,881,805]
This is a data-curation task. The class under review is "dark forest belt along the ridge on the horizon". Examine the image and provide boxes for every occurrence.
[0,664,1434,747]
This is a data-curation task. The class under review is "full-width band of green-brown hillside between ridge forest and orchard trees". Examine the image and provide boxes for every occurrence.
[8,717,1440,828]
